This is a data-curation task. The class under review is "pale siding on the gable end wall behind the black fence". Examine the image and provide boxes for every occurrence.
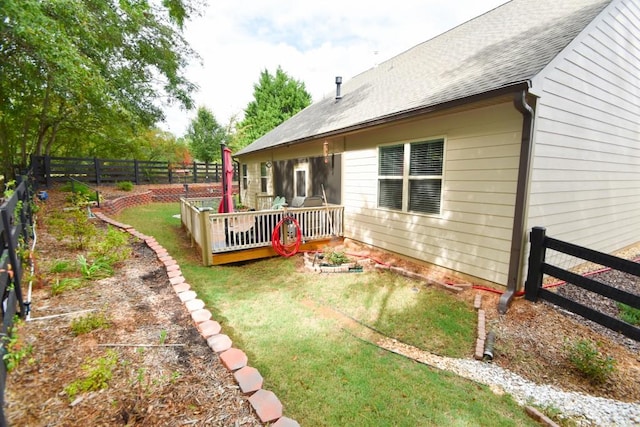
[528,1,640,260]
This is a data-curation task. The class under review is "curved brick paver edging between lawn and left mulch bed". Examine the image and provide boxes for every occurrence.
[94,211,300,427]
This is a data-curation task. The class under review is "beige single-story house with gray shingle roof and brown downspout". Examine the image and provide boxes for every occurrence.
[237,0,640,309]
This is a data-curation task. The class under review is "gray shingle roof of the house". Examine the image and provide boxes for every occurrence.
[237,0,611,155]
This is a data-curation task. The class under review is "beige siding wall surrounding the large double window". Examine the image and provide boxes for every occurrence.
[343,102,522,285]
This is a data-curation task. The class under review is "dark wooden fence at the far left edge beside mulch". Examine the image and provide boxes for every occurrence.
[0,176,33,426]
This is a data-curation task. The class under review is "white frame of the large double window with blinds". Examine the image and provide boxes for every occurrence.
[377,137,446,216]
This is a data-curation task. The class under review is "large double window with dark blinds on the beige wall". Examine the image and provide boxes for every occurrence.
[378,139,444,215]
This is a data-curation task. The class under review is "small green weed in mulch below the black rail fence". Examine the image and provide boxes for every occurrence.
[565,339,616,384]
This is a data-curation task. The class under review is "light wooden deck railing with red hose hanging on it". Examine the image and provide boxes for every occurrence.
[180,198,344,265]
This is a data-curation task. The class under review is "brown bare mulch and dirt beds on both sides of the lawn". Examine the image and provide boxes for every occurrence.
[5,186,640,426]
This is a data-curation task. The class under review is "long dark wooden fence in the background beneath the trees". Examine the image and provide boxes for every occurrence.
[31,156,238,187]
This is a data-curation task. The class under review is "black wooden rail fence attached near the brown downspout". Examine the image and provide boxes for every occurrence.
[525,227,640,341]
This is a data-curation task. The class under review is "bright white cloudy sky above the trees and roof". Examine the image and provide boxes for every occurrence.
[160,0,507,137]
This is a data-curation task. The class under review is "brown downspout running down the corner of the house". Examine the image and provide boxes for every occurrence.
[498,90,535,314]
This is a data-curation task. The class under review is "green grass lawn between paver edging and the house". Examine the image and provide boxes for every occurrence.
[118,203,536,426]
